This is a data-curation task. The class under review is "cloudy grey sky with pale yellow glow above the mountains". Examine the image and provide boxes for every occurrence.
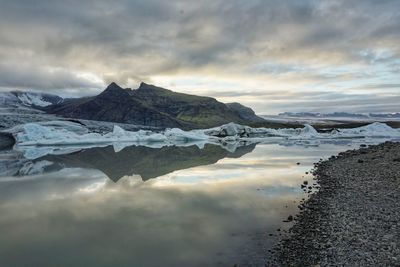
[0,0,400,114]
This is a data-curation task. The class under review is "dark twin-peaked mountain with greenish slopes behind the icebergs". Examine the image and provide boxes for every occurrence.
[43,83,263,129]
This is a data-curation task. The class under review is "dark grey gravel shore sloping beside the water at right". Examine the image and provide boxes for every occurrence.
[269,142,400,266]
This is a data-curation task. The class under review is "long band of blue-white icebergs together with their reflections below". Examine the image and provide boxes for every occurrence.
[9,121,400,159]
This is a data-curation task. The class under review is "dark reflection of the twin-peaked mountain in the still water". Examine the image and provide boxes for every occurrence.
[0,144,256,182]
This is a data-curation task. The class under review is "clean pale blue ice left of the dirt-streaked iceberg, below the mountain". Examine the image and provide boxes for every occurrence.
[8,121,210,151]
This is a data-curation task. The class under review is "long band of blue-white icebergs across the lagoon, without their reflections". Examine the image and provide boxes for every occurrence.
[9,121,400,146]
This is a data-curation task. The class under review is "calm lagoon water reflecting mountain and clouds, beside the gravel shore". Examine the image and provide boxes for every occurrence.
[0,144,366,267]
